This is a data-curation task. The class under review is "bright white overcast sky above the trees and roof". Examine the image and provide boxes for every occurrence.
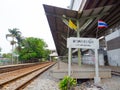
[0,0,71,53]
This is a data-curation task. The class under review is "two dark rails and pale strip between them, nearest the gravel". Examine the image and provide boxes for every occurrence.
[0,62,55,90]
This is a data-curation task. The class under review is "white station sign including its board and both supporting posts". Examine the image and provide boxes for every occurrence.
[67,37,100,83]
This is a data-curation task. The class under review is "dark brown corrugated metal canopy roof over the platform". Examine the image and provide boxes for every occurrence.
[44,0,120,56]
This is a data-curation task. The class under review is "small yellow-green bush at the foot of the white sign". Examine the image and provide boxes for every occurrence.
[59,76,77,90]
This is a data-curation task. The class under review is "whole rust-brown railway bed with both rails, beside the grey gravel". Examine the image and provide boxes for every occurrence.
[0,62,55,90]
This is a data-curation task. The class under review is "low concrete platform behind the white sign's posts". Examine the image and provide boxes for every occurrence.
[50,62,111,79]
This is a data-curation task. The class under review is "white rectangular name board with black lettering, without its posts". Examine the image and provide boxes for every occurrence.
[67,37,99,49]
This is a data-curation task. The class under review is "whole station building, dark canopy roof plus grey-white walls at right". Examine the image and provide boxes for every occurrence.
[44,0,120,66]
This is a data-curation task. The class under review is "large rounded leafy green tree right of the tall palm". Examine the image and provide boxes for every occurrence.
[19,37,49,62]
